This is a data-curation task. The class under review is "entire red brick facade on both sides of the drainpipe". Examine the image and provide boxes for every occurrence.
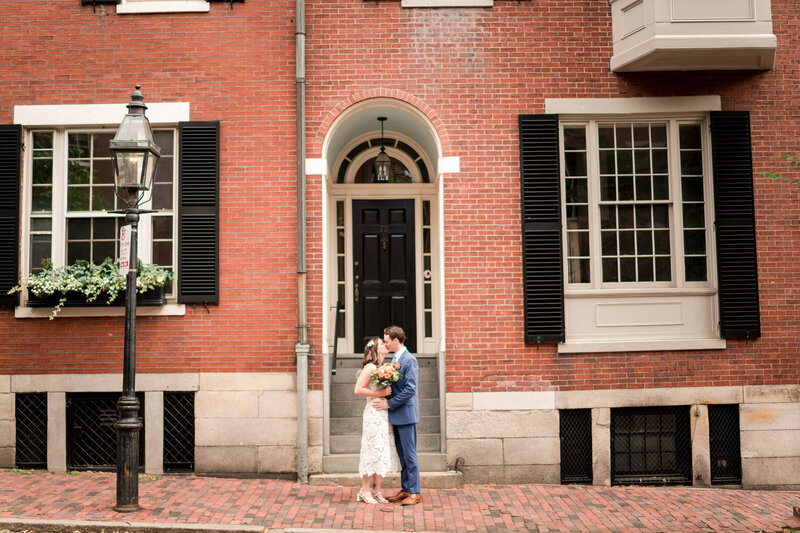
[0,0,800,391]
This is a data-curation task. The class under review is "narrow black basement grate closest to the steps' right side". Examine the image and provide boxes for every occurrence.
[558,409,593,483]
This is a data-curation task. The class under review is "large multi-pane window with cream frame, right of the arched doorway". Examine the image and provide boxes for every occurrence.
[562,120,708,287]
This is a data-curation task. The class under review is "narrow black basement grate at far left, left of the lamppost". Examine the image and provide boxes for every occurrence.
[14,392,47,468]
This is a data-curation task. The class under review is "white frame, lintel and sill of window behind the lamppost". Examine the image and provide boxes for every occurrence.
[14,102,190,318]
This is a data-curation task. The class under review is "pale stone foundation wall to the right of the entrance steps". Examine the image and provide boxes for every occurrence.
[446,385,800,489]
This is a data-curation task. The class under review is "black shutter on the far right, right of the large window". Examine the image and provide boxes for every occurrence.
[711,111,761,339]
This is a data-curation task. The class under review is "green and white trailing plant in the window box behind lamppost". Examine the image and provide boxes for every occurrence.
[8,258,173,320]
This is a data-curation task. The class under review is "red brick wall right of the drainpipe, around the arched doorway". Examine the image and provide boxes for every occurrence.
[307,0,800,392]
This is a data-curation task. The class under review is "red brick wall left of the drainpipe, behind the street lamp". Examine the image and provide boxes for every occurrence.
[0,0,297,373]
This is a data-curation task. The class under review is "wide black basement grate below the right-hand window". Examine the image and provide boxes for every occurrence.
[611,406,692,485]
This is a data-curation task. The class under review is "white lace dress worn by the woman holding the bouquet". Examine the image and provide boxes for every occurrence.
[358,363,400,476]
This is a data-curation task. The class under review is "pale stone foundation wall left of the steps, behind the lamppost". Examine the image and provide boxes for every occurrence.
[0,372,322,474]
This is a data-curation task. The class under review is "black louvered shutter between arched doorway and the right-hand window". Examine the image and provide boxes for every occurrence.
[519,115,564,343]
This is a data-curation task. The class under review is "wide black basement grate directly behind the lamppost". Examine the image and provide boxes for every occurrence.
[67,392,144,470]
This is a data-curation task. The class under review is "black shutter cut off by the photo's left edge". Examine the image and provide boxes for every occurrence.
[0,124,22,305]
